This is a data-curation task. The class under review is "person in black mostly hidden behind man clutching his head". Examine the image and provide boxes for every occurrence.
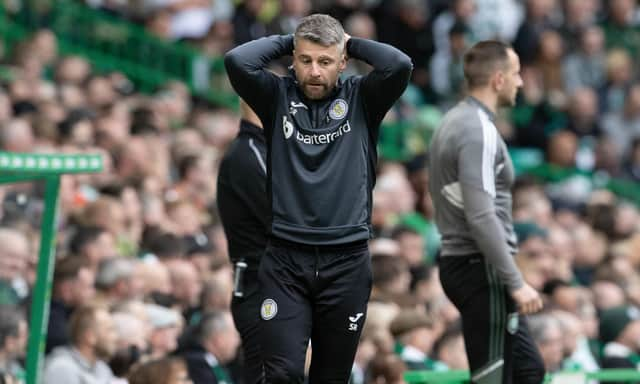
[216,102,269,384]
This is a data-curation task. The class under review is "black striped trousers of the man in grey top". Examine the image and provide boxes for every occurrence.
[439,255,545,384]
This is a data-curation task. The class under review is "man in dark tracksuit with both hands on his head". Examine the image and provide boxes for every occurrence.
[225,15,412,384]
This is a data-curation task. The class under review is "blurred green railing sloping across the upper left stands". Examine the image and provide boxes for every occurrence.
[0,0,237,108]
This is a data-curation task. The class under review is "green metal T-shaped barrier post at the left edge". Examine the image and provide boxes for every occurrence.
[0,152,102,384]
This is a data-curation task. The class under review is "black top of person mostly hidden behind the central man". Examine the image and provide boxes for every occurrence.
[216,120,269,261]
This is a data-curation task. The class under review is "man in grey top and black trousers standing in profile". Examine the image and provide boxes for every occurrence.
[429,41,544,384]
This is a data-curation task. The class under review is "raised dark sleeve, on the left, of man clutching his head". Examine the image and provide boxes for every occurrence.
[224,35,293,125]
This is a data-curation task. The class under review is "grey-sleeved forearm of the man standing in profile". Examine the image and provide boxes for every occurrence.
[462,186,524,291]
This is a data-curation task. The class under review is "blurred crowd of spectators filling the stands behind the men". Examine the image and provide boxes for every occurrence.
[0,0,640,384]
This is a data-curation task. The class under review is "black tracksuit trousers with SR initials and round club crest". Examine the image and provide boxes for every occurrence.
[258,239,372,384]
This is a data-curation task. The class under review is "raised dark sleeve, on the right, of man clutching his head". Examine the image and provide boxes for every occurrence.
[347,37,413,127]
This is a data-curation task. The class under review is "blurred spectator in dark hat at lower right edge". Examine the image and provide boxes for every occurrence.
[600,306,640,369]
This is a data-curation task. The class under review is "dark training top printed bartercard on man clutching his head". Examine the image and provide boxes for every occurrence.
[225,35,412,245]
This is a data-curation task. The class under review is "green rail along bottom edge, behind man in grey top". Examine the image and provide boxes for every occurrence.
[404,369,640,384]
